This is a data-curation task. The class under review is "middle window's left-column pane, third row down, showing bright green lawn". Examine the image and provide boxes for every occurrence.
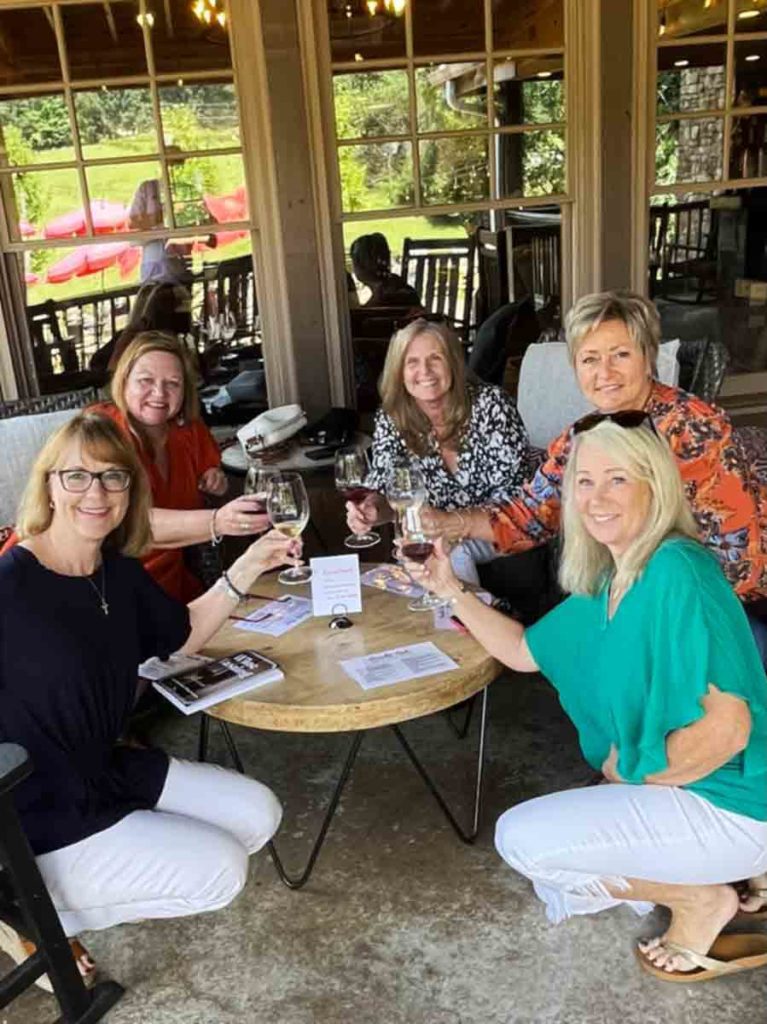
[338,142,415,213]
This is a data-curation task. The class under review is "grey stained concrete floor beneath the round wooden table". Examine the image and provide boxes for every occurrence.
[0,677,767,1024]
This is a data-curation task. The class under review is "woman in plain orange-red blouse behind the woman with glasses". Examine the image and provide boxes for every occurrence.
[94,331,267,602]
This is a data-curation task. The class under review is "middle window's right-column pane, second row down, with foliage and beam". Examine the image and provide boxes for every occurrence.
[495,54,564,125]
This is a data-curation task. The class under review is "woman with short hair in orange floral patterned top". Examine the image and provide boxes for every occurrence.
[422,292,767,662]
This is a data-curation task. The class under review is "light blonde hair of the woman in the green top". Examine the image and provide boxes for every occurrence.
[559,420,698,595]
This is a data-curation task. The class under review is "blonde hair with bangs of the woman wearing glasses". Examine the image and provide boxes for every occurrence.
[16,412,152,558]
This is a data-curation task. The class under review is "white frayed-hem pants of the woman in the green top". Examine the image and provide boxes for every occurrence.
[496,783,767,923]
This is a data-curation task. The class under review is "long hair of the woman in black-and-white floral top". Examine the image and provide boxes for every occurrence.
[378,316,471,456]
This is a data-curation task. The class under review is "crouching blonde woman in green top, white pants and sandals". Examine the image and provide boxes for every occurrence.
[411,411,767,981]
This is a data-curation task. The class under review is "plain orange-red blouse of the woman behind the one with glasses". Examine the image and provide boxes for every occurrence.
[90,402,221,604]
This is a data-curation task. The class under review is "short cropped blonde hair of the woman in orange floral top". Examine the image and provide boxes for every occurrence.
[564,291,661,375]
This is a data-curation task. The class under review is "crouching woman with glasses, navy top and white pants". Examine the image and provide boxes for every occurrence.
[0,411,299,982]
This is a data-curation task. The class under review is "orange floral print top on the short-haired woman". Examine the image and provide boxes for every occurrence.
[491,382,767,600]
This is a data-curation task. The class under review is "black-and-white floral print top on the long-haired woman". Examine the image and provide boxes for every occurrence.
[366,383,528,511]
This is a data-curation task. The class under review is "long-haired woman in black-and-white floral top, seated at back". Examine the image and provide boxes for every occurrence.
[346,318,528,583]
